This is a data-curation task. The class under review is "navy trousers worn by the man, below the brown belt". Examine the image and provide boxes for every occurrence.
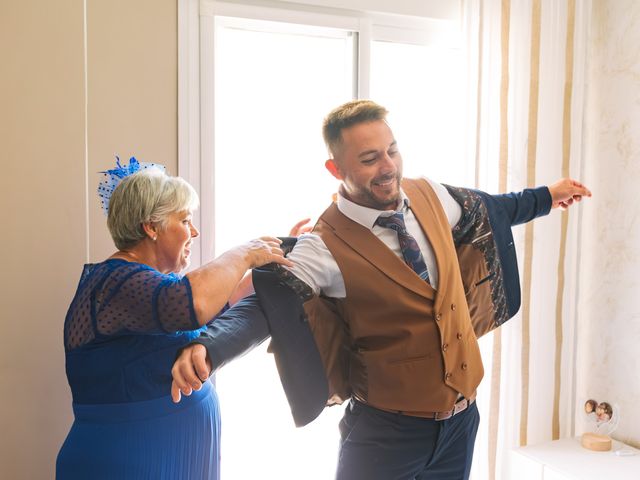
[336,400,480,480]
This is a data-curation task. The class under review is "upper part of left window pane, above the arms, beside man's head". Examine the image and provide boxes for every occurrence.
[215,21,353,252]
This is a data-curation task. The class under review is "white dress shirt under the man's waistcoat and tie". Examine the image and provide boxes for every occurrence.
[287,178,462,298]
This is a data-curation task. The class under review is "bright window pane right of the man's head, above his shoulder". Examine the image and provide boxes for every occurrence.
[371,41,473,185]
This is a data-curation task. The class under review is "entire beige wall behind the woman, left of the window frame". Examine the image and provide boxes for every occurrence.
[0,0,177,480]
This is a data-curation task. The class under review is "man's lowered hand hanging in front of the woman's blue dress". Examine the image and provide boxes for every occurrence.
[171,343,211,403]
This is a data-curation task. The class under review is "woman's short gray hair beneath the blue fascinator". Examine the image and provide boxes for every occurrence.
[107,168,199,250]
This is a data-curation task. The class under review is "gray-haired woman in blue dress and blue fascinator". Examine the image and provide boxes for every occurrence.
[56,159,290,480]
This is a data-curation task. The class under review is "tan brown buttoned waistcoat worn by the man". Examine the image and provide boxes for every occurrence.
[305,179,484,416]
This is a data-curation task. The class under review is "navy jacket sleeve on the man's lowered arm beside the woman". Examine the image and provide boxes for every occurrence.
[192,295,270,372]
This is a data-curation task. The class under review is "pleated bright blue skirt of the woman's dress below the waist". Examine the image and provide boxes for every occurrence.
[56,381,220,480]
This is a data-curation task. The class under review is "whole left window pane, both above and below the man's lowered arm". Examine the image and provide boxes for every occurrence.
[215,15,354,480]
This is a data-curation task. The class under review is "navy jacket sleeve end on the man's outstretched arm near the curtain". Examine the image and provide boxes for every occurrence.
[488,187,551,226]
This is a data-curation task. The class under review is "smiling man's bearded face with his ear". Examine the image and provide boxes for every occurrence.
[325,120,402,210]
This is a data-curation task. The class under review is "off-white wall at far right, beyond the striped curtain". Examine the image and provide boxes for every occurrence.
[576,0,640,446]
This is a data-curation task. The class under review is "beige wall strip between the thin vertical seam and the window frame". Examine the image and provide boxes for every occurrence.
[87,0,178,262]
